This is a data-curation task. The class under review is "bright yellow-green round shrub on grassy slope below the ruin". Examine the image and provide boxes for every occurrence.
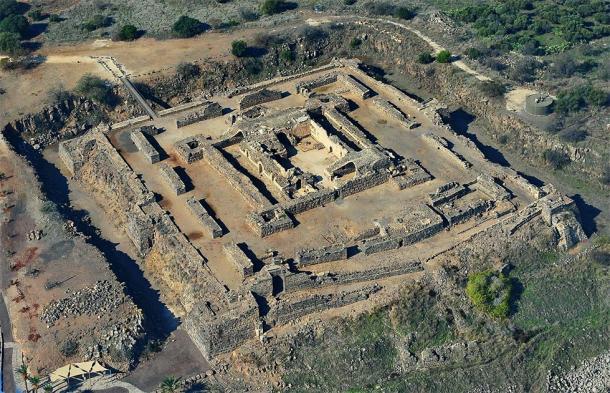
[466,270,513,318]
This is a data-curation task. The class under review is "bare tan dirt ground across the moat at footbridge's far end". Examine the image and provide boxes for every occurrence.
[0,25,261,122]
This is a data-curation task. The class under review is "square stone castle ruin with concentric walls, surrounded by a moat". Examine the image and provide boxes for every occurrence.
[59,60,585,358]
